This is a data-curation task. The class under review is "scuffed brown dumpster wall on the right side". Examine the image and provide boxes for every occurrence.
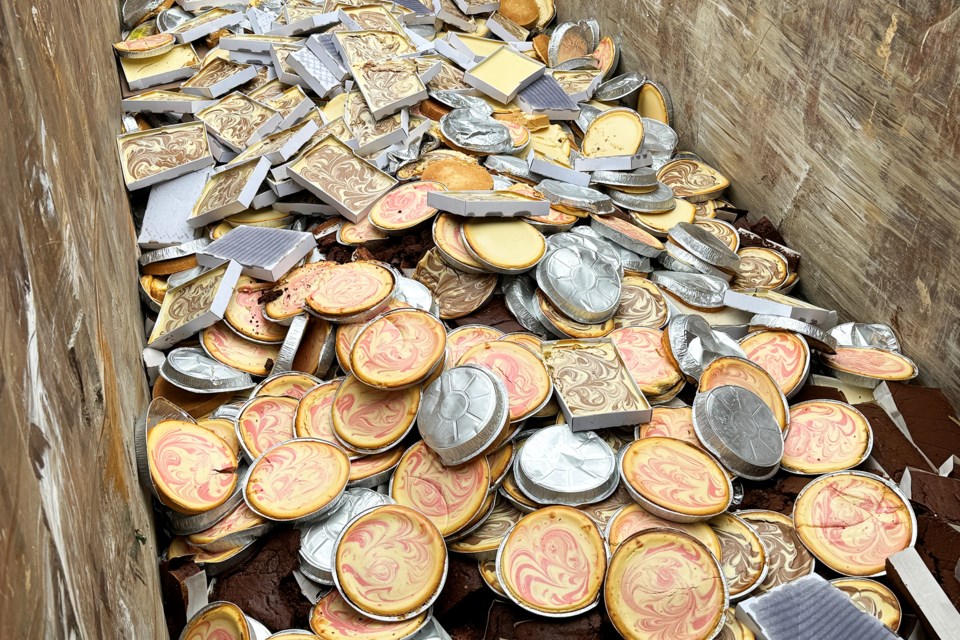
[558,0,960,404]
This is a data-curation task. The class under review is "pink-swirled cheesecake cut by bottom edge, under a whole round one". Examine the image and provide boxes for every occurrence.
[310,589,429,640]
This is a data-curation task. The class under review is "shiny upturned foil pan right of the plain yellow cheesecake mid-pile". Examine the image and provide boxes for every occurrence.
[537,247,621,324]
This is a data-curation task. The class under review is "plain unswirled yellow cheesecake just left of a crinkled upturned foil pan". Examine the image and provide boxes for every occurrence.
[461,218,547,273]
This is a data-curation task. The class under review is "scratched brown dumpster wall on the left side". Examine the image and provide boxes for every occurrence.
[0,0,165,638]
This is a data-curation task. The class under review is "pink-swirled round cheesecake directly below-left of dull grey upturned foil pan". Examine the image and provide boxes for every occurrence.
[620,437,733,522]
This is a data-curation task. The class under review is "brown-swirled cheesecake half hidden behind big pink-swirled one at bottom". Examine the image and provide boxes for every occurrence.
[708,513,767,598]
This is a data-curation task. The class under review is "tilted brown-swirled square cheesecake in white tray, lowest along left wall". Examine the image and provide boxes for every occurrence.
[147,262,241,349]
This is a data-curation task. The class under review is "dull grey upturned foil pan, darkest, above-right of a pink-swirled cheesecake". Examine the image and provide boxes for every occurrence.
[693,386,783,480]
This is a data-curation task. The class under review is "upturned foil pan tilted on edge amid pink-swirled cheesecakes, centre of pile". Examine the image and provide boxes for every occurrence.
[417,365,509,465]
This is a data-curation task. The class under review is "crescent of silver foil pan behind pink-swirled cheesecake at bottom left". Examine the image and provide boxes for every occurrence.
[300,489,393,586]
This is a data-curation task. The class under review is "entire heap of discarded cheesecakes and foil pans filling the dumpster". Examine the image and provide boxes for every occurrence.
[115,0,948,640]
